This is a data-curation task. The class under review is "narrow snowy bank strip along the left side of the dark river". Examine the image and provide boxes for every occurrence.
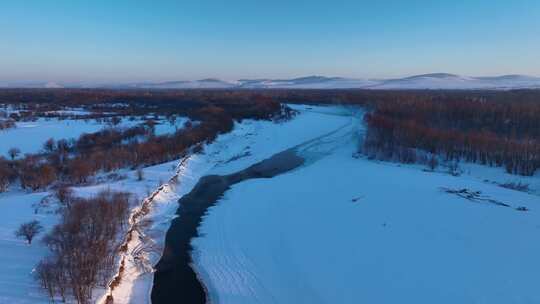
[93,105,343,304]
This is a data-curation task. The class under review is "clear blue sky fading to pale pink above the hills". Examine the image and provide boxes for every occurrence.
[0,0,540,81]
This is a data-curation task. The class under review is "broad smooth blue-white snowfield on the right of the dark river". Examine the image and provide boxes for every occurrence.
[193,105,540,304]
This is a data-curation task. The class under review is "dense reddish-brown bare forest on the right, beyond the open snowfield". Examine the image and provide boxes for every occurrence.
[364,99,540,175]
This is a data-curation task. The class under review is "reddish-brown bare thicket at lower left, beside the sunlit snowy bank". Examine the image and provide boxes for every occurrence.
[35,191,129,304]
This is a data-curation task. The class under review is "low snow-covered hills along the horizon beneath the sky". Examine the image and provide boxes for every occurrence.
[0,73,540,90]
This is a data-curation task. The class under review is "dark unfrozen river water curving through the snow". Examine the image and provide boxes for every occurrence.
[151,149,304,304]
